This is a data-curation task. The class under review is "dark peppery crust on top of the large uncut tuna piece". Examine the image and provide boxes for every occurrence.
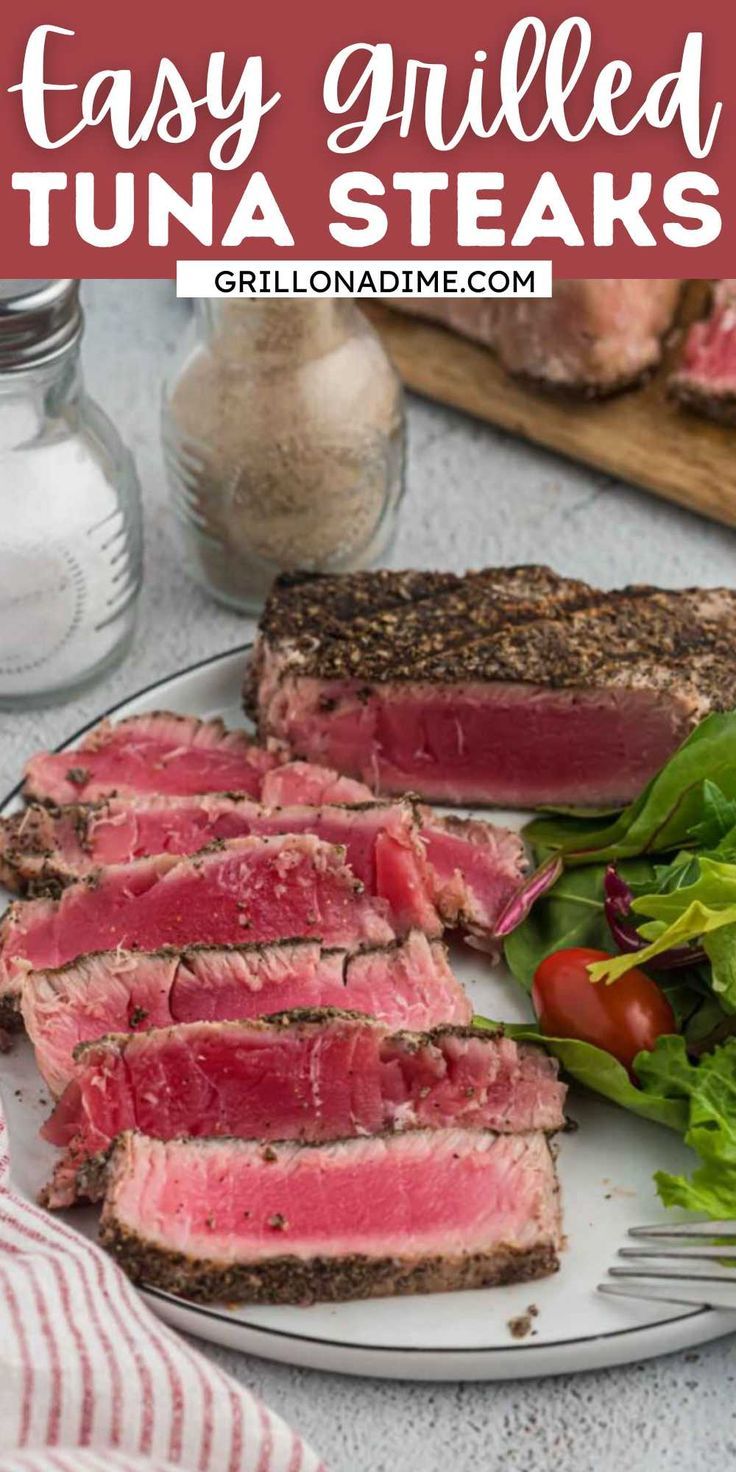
[246,567,736,709]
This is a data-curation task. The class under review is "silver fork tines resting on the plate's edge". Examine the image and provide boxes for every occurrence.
[598,1222,736,1310]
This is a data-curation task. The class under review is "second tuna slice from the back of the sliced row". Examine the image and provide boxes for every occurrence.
[0,800,524,935]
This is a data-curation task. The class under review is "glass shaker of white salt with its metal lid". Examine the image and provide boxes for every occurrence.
[0,280,141,710]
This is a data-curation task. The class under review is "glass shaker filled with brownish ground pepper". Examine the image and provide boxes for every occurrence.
[162,299,405,612]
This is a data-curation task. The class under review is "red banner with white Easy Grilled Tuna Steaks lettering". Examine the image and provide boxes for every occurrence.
[0,0,736,277]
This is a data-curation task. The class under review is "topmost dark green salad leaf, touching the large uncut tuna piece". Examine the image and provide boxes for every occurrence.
[524,711,736,864]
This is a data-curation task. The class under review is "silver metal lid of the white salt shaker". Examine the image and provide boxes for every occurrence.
[0,278,84,372]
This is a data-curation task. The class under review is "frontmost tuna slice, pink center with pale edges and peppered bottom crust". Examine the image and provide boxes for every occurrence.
[100,1129,561,1303]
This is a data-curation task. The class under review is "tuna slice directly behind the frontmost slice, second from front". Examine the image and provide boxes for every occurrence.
[41,1011,565,1207]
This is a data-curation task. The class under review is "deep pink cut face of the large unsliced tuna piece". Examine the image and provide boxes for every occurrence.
[265,676,692,807]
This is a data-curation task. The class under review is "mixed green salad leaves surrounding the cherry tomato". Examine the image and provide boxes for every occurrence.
[505,711,736,1217]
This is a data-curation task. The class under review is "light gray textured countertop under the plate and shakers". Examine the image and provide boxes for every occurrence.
[0,281,736,1472]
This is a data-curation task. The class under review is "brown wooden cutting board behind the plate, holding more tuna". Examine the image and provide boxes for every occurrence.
[367,293,736,527]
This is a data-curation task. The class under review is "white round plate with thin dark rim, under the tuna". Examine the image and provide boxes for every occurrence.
[1,651,736,1381]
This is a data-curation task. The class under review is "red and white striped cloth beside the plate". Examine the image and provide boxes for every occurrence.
[0,1110,324,1472]
